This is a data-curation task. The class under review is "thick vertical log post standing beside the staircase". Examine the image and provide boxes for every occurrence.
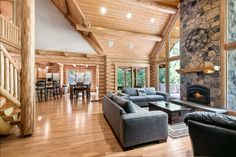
[20,0,35,137]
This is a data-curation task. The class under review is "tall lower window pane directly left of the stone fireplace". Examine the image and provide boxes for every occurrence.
[169,60,180,98]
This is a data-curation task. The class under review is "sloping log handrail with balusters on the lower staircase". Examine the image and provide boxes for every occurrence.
[0,43,20,106]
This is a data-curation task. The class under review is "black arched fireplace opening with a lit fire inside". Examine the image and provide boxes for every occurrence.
[187,85,210,105]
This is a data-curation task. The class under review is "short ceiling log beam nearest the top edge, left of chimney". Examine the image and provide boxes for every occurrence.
[122,0,178,14]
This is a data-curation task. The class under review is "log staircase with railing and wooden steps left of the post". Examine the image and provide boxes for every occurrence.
[0,43,21,135]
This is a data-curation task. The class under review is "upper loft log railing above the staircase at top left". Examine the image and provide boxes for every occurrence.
[0,14,21,49]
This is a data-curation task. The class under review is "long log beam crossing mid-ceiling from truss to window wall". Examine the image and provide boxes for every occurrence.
[76,24,162,41]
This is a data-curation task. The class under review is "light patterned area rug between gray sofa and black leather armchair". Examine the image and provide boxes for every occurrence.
[168,123,189,138]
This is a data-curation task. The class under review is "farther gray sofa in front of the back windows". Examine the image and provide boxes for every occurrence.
[118,87,169,107]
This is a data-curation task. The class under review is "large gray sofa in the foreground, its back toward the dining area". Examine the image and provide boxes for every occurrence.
[102,94,168,149]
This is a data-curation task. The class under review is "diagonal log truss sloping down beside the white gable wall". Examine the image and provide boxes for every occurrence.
[52,0,104,54]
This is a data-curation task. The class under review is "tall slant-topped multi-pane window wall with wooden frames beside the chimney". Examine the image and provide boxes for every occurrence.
[157,19,180,98]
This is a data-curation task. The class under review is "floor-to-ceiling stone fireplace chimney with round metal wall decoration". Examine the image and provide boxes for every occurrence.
[180,0,224,108]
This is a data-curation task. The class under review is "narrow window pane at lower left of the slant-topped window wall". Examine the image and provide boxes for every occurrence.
[158,64,166,92]
